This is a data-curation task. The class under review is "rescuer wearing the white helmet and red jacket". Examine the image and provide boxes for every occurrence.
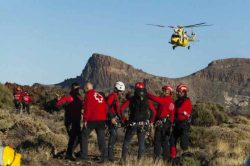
[107,81,125,161]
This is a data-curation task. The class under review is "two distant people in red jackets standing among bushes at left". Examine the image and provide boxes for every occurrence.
[13,87,32,114]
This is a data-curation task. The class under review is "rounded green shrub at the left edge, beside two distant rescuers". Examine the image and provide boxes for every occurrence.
[0,83,14,109]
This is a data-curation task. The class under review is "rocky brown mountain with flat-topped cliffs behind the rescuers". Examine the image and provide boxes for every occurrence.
[58,54,250,114]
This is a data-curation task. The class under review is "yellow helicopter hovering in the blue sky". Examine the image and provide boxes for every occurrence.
[147,22,211,50]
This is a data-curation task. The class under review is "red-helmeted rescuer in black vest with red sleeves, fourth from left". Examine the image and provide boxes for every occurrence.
[120,82,156,164]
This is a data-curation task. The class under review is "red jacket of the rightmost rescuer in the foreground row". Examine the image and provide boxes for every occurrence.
[175,98,192,121]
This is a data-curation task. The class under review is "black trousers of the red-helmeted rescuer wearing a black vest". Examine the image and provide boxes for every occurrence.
[122,126,146,161]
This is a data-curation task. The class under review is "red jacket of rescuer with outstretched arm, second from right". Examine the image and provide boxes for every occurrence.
[147,94,175,123]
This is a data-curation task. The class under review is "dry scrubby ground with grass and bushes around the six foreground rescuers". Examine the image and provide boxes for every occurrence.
[0,106,250,166]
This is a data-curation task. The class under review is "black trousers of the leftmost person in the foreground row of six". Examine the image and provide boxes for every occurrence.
[67,120,81,156]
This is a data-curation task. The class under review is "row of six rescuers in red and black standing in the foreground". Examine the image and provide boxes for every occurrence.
[56,81,192,164]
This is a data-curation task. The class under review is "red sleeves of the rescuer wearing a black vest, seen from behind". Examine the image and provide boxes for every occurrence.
[120,99,156,123]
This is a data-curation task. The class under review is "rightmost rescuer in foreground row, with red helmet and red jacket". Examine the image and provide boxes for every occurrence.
[170,83,192,160]
